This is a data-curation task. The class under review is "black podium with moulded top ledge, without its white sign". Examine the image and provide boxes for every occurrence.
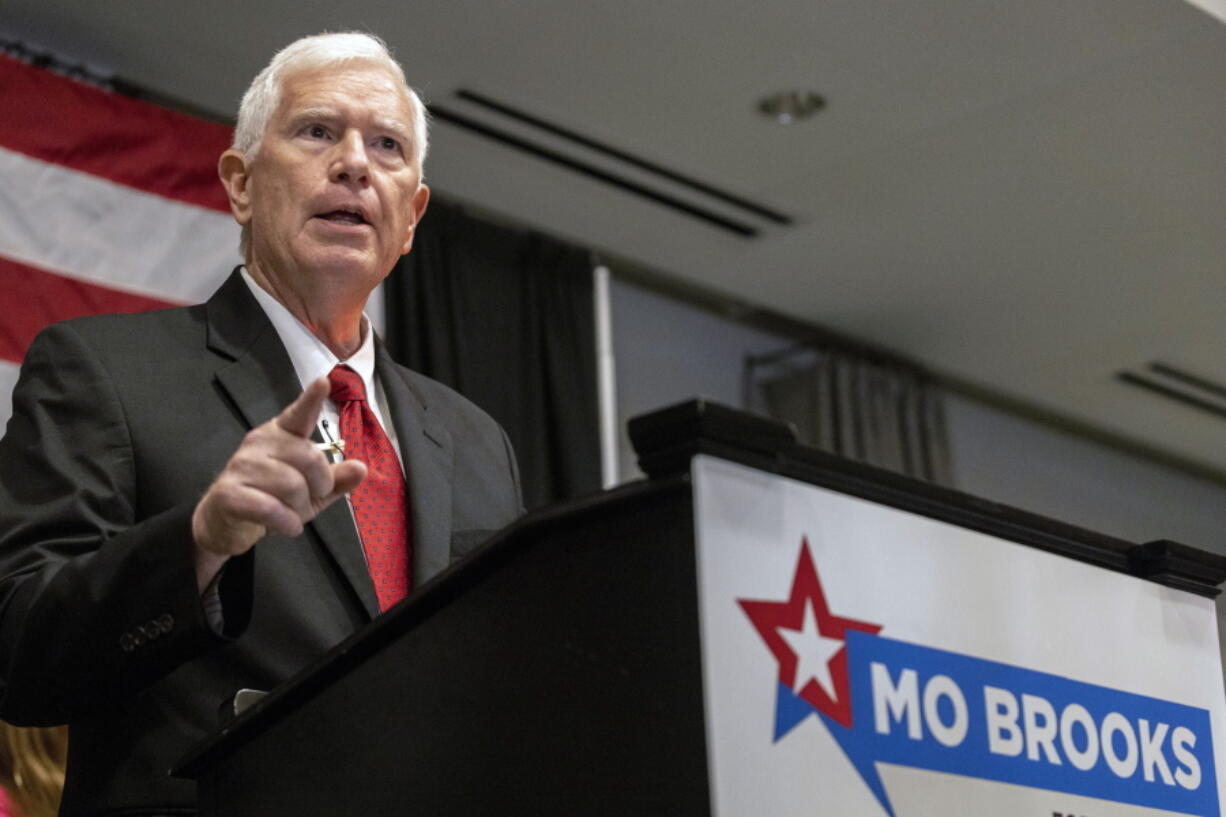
[175,401,1226,817]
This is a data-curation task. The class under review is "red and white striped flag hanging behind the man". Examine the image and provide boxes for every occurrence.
[0,55,239,421]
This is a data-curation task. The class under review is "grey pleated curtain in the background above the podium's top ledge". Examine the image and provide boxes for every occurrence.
[745,348,951,485]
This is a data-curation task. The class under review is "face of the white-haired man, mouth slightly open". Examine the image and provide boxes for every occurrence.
[232,64,429,298]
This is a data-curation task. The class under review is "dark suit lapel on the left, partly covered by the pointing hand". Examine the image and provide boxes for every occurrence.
[207,271,379,617]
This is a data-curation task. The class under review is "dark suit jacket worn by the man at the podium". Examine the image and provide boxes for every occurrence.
[0,274,521,815]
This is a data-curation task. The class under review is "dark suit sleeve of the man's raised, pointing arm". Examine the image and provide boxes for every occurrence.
[0,324,224,724]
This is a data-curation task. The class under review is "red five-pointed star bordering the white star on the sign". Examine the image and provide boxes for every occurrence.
[737,537,881,729]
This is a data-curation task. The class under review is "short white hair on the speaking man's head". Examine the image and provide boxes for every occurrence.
[230,31,429,258]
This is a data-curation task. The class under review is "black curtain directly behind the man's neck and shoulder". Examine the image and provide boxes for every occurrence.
[386,199,601,508]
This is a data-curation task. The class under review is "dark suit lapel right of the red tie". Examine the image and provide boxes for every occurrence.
[375,339,452,586]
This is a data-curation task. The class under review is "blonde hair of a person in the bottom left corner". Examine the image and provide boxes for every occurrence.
[0,721,69,817]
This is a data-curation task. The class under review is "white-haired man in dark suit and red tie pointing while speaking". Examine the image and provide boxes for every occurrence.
[0,33,521,815]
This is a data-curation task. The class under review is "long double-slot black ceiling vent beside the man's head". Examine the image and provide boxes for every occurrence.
[429,88,792,238]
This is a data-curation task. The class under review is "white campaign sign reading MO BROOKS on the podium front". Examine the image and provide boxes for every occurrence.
[693,458,1226,817]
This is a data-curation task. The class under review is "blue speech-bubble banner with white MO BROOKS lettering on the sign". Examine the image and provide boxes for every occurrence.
[804,631,1220,817]
